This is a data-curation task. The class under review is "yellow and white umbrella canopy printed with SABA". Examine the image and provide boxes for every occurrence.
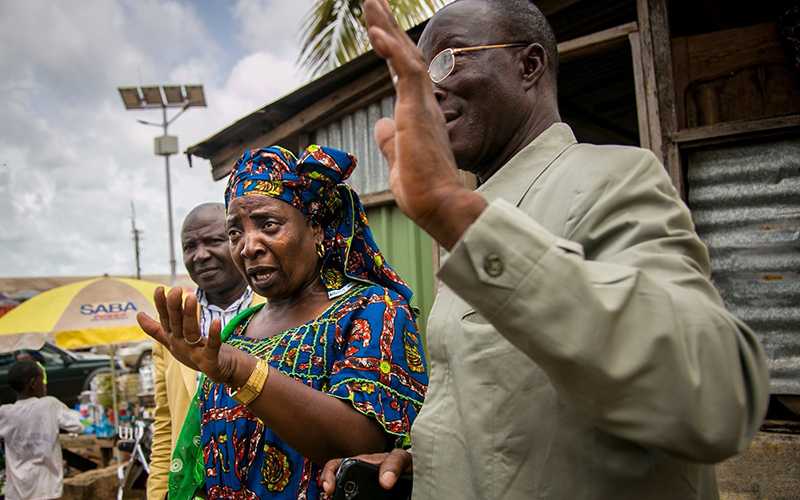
[0,278,164,352]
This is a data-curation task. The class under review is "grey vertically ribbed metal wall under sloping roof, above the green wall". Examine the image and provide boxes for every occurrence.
[310,95,394,194]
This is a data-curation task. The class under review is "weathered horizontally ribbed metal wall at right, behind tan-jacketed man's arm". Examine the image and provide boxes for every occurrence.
[688,139,800,394]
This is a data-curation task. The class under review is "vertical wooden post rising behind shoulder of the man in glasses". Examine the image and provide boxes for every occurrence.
[634,0,686,198]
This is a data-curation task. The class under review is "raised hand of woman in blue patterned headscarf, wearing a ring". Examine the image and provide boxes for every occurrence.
[136,287,248,383]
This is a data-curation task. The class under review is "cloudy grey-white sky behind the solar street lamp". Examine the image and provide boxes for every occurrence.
[0,0,312,277]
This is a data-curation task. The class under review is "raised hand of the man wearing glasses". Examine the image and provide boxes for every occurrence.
[364,0,486,249]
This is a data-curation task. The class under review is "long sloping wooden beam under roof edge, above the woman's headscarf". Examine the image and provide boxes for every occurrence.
[210,65,389,180]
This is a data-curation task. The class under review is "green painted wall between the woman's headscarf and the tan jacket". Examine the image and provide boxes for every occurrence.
[367,204,434,334]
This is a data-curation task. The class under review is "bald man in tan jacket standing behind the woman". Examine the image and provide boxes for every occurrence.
[147,203,263,500]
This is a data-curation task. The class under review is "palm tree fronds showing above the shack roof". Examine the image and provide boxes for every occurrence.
[299,0,447,76]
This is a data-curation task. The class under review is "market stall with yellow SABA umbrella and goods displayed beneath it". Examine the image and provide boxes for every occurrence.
[0,277,163,446]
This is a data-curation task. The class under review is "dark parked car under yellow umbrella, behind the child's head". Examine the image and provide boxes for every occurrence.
[0,343,119,408]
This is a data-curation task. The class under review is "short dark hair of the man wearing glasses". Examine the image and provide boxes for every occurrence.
[456,0,558,79]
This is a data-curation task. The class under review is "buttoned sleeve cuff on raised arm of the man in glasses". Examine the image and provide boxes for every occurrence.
[438,199,583,318]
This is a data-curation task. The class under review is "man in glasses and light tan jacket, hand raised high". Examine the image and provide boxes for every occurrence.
[324,0,768,500]
